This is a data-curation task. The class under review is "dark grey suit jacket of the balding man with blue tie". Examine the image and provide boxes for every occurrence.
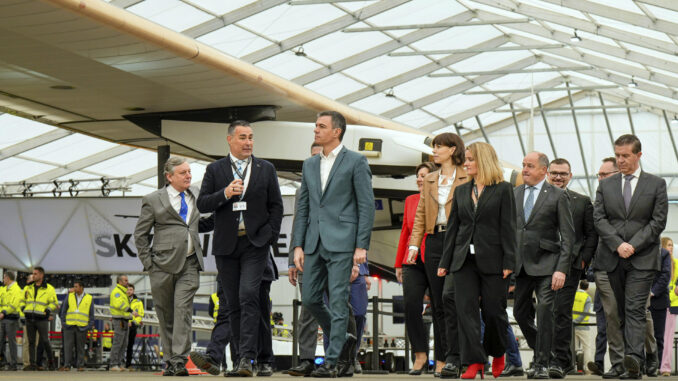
[514,182,574,276]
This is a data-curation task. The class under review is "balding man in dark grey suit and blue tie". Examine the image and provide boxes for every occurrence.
[513,152,575,379]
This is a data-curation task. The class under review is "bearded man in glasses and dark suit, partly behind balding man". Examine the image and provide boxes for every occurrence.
[549,159,598,378]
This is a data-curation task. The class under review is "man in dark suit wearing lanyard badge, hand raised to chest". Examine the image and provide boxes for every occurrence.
[196,120,283,377]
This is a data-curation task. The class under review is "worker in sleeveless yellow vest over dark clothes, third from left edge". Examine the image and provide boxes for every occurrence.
[59,280,94,372]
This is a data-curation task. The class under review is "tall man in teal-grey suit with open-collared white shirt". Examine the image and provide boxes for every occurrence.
[291,111,374,377]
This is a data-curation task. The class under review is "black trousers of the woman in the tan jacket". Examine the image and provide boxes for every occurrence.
[424,233,452,361]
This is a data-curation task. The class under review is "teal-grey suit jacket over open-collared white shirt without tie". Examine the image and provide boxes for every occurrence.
[291,147,374,254]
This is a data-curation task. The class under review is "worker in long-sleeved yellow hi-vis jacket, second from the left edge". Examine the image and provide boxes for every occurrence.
[21,266,59,370]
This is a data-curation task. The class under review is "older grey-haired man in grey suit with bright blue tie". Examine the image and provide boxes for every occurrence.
[134,157,211,376]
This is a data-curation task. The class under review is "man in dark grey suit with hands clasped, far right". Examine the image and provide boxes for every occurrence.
[593,134,668,379]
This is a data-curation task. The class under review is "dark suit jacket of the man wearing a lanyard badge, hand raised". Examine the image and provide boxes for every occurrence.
[197,156,283,255]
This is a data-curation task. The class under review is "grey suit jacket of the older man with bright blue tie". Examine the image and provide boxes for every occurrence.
[134,188,205,274]
